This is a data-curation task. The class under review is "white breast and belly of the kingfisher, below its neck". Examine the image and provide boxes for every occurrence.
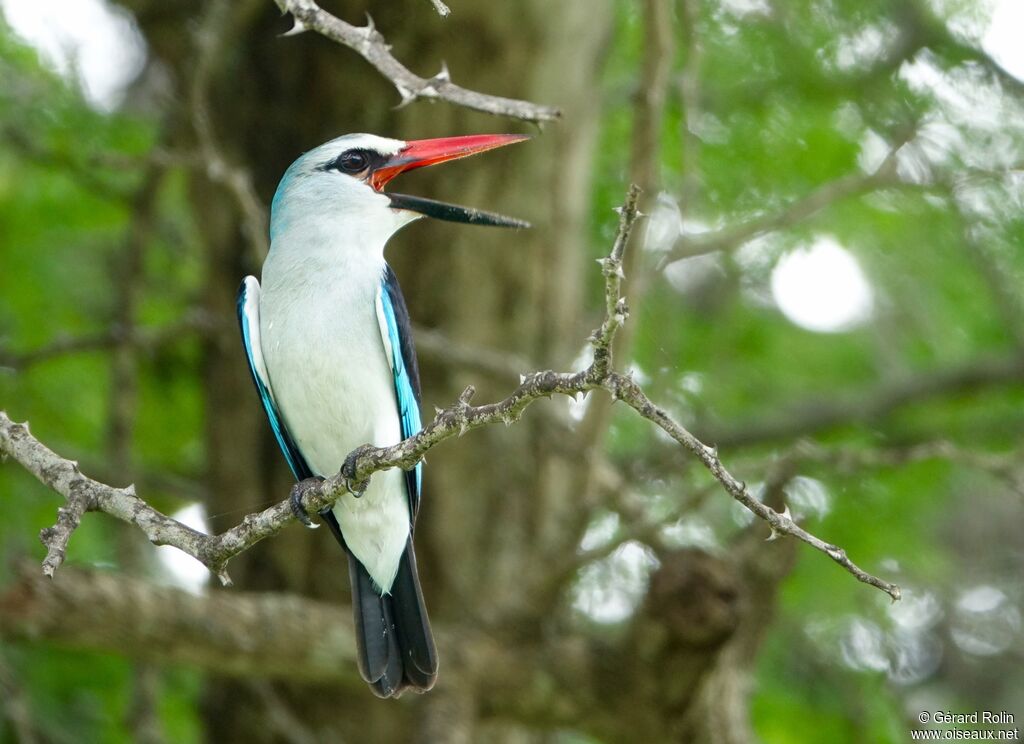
[260,244,410,590]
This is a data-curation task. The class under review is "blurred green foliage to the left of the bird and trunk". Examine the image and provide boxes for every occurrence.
[0,18,202,743]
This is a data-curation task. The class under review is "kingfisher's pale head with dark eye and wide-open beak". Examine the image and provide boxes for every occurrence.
[270,134,529,246]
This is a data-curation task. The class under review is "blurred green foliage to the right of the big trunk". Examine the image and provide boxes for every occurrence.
[593,1,1024,742]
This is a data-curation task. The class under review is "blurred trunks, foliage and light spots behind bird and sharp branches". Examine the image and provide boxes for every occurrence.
[0,0,1024,744]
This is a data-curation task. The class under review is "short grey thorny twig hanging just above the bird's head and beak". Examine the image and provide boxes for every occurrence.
[274,0,561,122]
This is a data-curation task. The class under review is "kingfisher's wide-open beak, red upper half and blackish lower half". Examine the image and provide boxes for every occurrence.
[369,134,529,227]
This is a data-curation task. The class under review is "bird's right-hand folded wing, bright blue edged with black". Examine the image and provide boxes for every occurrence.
[377,264,423,521]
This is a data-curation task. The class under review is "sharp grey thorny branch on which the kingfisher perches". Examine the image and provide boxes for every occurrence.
[0,186,900,600]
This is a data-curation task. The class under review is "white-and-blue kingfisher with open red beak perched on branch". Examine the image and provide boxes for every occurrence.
[237,134,528,698]
